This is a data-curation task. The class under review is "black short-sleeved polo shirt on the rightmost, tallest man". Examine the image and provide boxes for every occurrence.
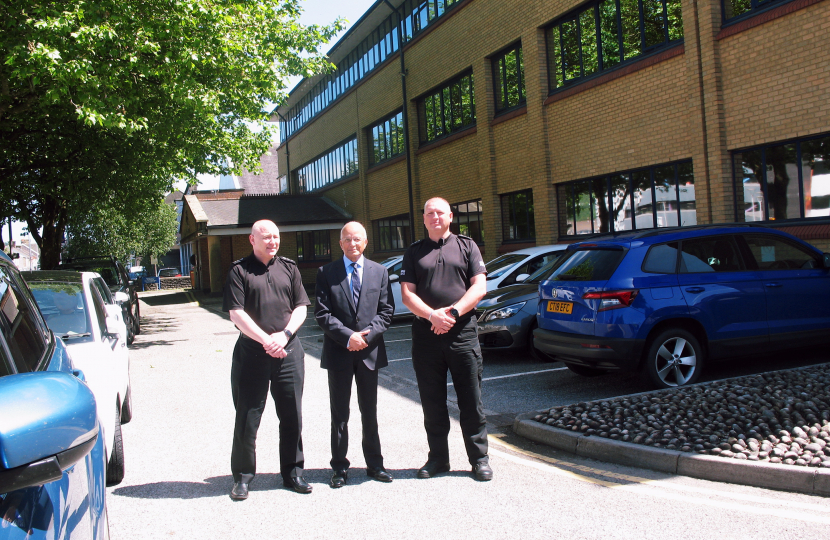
[401,234,487,309]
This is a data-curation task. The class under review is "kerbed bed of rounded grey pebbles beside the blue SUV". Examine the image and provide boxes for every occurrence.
[534,364,830,467]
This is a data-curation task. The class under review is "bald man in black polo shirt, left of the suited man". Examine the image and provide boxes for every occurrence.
[222,220,311,500]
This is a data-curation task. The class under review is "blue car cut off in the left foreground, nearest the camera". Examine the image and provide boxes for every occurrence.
[0,252,109,540]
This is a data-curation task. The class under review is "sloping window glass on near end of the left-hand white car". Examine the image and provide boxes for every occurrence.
[29,281,92,342]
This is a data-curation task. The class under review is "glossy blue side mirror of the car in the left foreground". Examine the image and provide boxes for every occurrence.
[0,371,98,493]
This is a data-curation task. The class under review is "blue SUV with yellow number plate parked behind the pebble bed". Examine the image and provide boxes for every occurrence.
[534,226,830,388]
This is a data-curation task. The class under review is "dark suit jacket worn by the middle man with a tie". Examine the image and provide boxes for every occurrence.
[314,257,395,370]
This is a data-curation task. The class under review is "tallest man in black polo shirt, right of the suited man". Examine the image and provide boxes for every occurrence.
[401,197,493,481]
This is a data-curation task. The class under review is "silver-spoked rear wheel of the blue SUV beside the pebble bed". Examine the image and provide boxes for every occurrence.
[645,328,704,388]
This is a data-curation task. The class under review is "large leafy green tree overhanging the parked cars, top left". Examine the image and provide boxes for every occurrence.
[0,0,342,269]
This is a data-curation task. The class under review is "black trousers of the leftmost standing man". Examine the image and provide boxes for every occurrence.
[231,338,305,483]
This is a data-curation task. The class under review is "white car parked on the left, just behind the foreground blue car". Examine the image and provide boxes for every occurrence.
[22,270,132,486]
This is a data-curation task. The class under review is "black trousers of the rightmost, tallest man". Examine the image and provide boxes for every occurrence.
[412,317,488,465]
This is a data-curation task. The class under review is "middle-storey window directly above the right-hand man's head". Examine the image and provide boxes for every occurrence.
[418,73,476,143]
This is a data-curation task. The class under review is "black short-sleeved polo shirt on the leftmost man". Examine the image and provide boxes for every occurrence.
[222,253,311,334]
